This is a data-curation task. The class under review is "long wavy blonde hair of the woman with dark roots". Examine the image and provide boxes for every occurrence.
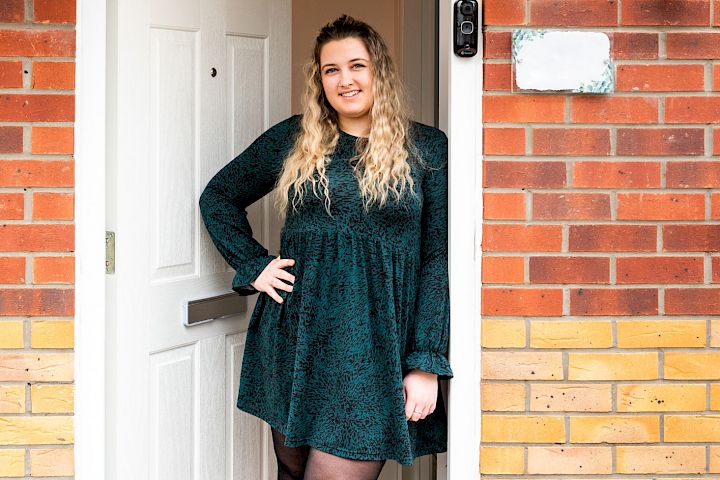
[275,15,422,217]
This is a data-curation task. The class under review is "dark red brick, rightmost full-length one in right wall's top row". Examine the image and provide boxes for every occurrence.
[621,0,710,26]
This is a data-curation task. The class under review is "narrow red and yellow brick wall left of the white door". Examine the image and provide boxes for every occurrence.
[0,0,75,478]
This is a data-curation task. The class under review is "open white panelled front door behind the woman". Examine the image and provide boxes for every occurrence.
[106,0,291,480]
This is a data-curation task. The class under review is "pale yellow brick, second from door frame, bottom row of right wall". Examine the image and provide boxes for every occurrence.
[528,447,612,475]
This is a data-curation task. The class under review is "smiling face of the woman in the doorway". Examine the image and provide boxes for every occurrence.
[320,38,374,130]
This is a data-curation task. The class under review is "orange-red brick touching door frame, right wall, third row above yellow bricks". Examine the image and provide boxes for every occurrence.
[483,223,562,252]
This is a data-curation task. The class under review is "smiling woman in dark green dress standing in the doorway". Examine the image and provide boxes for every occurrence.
[200,16,453,480]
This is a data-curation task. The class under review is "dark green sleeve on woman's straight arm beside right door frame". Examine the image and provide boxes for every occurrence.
[403,130,453,379]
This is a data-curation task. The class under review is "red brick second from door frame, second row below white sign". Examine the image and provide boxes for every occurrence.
[533,128,610,155]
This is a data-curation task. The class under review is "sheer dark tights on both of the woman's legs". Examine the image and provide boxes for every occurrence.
[272,428,385,480]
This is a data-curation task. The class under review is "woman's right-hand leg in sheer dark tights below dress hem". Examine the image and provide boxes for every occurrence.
[305,448,385,480]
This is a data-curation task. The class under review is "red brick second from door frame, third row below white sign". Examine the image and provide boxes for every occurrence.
[573,162,660,188]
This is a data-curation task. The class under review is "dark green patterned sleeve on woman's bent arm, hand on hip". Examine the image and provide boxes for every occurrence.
[199,115,299,295]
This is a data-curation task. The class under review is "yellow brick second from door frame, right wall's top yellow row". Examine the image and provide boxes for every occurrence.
[530,321,612,348]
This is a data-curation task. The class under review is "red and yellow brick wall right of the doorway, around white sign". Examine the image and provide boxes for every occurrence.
[481,0,720,478]
